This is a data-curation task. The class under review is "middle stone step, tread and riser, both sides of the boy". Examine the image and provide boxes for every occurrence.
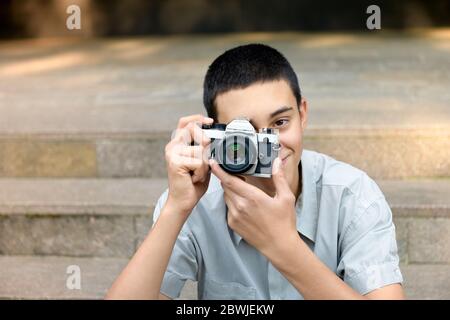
[0,179,450,264]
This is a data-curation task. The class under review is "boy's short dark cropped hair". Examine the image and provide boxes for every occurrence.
[203,43,301,121]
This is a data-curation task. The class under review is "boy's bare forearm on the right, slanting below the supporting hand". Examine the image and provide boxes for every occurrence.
[267,236,365,299]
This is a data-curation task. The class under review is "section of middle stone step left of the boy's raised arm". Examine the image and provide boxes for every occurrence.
[0,179,167,257]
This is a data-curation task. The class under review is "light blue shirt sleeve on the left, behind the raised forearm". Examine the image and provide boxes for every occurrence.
[153,191,198,299]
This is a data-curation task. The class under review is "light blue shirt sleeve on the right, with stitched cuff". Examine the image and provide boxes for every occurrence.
[337,197,403,295]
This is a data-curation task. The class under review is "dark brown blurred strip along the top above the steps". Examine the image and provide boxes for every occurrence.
[0,0,450,37]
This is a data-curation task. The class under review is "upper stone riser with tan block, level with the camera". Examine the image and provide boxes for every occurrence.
[0,124,450,179]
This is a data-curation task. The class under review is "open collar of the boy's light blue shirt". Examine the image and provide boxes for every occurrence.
[229,150,318,245]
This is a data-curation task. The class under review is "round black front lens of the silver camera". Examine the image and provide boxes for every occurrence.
[219,135,257,174]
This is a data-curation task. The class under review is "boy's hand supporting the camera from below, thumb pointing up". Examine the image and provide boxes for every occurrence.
[210,158,298,257]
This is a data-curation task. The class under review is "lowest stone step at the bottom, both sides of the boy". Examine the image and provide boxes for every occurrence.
[0,256,450,299]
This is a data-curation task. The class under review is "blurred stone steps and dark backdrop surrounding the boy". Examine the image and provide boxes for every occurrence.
[0,0,450,299]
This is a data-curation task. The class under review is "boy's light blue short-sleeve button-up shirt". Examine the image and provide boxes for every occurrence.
[153,150,403,299]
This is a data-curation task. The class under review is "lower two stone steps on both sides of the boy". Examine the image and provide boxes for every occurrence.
[0,178,450,299]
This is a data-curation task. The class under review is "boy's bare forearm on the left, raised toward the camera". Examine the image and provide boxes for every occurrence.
[106,204,185,299]
